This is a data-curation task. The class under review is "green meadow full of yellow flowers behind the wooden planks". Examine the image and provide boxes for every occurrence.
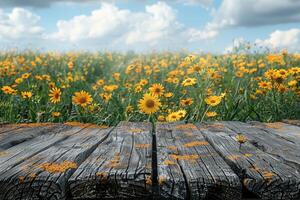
[0,51,300,125]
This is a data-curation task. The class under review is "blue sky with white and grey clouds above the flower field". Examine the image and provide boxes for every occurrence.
[0,0,300,53]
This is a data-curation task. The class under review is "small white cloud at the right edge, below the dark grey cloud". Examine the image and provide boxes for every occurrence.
[255,28,300,51]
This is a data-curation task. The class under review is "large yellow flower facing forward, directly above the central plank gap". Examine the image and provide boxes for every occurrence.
[138,94,161,114]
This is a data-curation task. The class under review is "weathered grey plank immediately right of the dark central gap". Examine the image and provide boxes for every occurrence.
[156,123,241,199]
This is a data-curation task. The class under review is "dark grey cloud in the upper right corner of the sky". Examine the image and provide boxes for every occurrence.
[209,0,300,28]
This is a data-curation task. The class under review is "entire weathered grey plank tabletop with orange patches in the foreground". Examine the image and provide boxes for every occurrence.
[0,121,300,200]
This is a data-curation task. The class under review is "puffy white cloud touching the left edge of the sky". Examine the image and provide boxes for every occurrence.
[0,8,43,40]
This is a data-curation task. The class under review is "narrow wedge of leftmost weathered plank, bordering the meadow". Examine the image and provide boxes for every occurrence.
[0,124,66,151]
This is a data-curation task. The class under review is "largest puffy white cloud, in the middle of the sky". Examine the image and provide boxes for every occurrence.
[48,2,214,49]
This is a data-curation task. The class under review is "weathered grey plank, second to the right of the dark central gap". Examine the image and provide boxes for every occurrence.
[198,122,300,200]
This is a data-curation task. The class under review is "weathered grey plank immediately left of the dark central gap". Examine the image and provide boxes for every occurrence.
[69,122,152,199]
